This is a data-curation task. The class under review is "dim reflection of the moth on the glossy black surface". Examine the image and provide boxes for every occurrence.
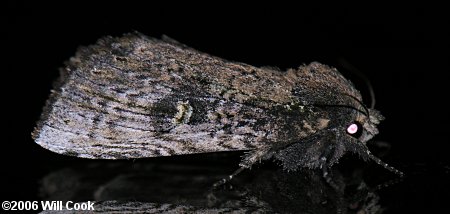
[39,163,389,214]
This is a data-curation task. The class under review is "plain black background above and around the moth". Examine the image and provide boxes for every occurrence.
[0,1,450,212]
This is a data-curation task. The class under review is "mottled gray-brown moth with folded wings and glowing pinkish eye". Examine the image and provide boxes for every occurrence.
[32,33,402,184]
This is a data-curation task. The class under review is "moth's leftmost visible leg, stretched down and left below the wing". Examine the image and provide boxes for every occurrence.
[213,148,272,188]
